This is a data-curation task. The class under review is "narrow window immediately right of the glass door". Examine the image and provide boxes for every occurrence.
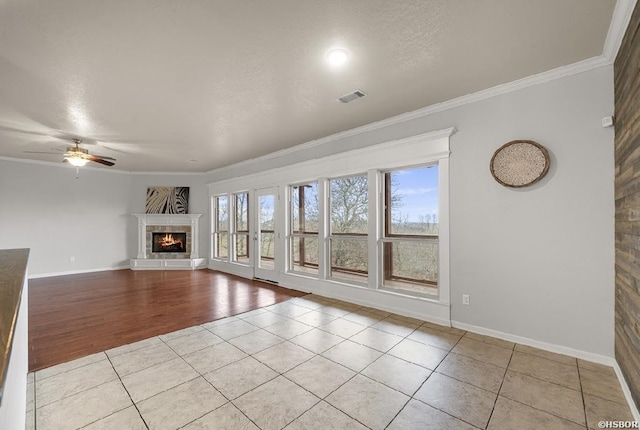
[289,182,318,275]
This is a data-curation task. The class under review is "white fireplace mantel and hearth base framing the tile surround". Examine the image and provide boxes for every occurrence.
[131,214,206,270]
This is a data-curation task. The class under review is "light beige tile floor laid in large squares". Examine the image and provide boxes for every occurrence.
[27,295,633,430]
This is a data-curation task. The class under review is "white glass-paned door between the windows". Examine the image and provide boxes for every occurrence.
[253,188,278,283]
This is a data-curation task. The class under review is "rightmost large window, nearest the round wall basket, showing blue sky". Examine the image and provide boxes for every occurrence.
[382,166,438,295]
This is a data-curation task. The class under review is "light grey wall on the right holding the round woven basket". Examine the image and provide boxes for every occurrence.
[207,66,614,358]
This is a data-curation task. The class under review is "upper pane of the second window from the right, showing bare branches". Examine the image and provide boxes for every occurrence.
[330,175,368,234]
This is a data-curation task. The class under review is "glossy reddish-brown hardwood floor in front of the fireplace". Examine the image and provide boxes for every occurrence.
[29,270,305,371]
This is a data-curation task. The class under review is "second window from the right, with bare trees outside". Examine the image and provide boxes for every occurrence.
[329,175,369,283]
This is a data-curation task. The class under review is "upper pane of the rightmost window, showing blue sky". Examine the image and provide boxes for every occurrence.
[385,166,438,235]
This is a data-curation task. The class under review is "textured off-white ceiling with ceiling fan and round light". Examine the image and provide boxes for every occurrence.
[0,0,615,172]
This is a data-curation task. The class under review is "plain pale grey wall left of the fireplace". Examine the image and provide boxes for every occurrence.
[0,160,135,276]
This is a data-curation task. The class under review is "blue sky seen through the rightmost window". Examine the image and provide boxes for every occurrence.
[392,166,438,222]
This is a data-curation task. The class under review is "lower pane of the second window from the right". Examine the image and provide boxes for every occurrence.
[331,238,368,282]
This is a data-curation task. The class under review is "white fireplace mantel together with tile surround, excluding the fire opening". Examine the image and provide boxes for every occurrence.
[131,214,206,270]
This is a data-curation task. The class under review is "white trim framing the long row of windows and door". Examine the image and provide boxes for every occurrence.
[207,127,456,325]
